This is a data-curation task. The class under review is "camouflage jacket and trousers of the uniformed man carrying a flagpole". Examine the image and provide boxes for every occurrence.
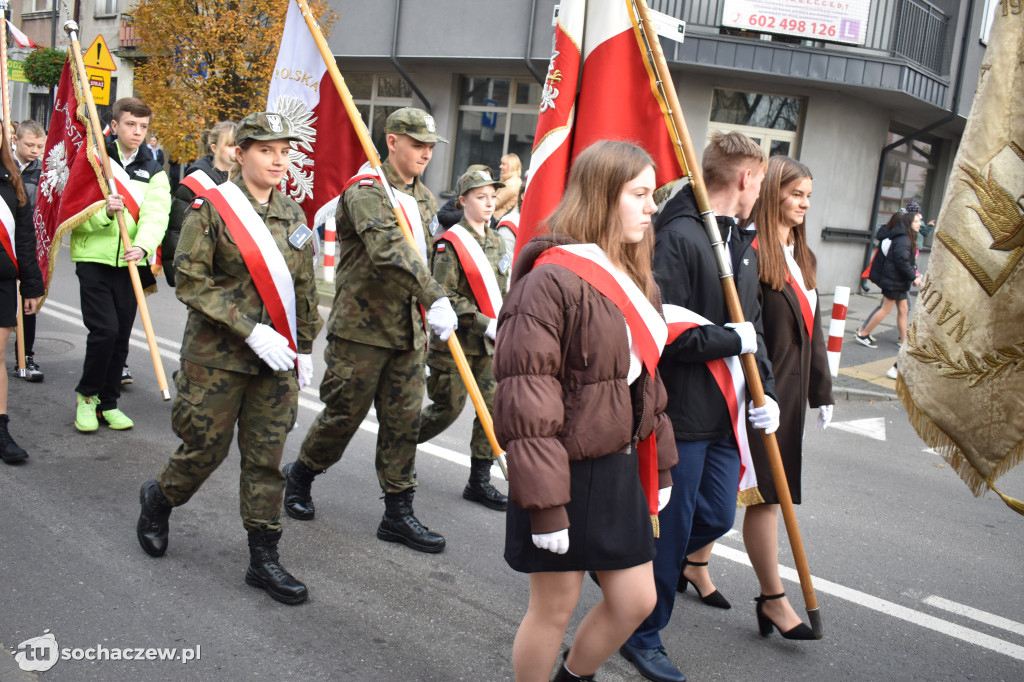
[299,162,444,493]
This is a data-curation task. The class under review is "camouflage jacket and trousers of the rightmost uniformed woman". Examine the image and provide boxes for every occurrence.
[420,212,512,460]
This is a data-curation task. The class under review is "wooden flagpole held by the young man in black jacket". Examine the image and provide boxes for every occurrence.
[627,0,824,639]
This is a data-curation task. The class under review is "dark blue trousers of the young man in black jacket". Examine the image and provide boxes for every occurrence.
[630,438,739,649]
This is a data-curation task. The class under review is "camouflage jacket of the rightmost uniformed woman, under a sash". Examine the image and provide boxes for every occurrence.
[428,218,512,367]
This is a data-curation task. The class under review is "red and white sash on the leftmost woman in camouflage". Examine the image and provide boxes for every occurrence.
[199,181,298,352]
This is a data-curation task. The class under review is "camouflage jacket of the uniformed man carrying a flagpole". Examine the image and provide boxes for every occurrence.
[328,162,444,350]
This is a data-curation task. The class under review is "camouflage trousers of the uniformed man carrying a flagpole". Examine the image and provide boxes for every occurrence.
[299,336,426,493]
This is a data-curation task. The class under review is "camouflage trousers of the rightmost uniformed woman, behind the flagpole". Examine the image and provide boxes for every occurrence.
[419,351,498,460]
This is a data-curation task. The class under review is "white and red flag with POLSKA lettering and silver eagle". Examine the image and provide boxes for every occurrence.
[266,0,367,226]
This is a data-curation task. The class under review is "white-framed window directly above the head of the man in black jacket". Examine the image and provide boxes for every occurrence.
[707,88,804,159]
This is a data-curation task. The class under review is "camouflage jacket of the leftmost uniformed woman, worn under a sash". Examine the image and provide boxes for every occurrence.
[174,177,324,374]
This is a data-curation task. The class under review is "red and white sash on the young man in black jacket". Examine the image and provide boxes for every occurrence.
[663,305,758,493]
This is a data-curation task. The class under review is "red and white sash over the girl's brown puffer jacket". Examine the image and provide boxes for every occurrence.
[534,244,669,522]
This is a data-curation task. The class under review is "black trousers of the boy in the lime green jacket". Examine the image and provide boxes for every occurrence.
[75,263,138,411]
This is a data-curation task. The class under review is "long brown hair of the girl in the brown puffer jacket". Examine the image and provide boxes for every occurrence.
[548,140,656,302]
